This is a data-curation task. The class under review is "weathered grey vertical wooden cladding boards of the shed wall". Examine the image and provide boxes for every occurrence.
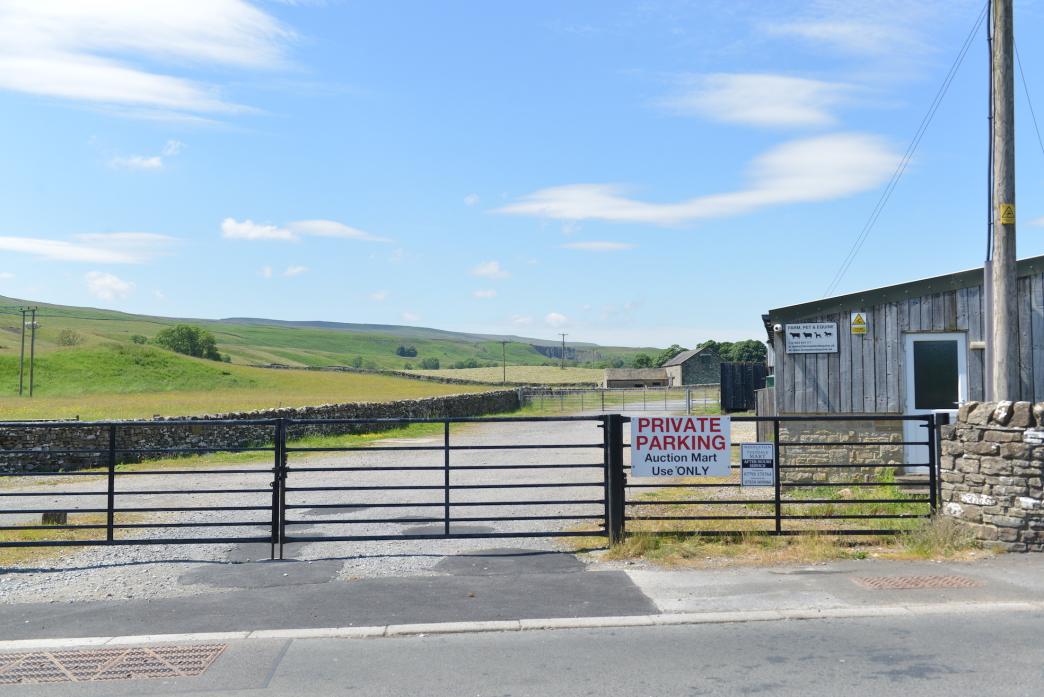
[769,266,1044,413]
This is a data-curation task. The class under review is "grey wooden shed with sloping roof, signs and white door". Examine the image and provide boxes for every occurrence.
[759,257,1044,446]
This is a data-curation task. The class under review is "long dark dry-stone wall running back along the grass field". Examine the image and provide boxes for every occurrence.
[0,389,521,472]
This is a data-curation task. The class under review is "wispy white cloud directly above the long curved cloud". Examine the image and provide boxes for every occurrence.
[660,73,852,126]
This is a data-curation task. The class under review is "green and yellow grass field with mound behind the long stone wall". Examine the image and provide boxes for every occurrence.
[0,344,489,419]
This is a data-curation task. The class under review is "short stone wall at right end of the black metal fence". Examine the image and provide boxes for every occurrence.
[940,402,1044,552]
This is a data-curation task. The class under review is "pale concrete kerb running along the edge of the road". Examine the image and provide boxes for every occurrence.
[0,601,1044,651]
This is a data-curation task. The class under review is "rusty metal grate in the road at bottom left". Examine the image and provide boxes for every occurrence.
[0,644,226,684]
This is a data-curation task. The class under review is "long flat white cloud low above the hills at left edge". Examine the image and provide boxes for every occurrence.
[0,233,176,264]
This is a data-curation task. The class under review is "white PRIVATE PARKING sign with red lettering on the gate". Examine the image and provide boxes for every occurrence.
[631,416,732,477]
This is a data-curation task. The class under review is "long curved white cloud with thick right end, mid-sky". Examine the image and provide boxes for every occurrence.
[499,134,899,225]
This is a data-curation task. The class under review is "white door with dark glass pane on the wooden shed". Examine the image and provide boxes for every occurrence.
[903,332,968,467]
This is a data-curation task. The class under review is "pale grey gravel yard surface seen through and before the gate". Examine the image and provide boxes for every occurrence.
[0,413,753,603]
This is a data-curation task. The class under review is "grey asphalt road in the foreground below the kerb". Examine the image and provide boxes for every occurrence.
[6,612,1044,697]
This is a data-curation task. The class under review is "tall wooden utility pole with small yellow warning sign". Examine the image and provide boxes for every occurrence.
[990,0,1020,400]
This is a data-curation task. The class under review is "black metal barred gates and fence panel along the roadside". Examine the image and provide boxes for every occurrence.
[0,414,938,558]
